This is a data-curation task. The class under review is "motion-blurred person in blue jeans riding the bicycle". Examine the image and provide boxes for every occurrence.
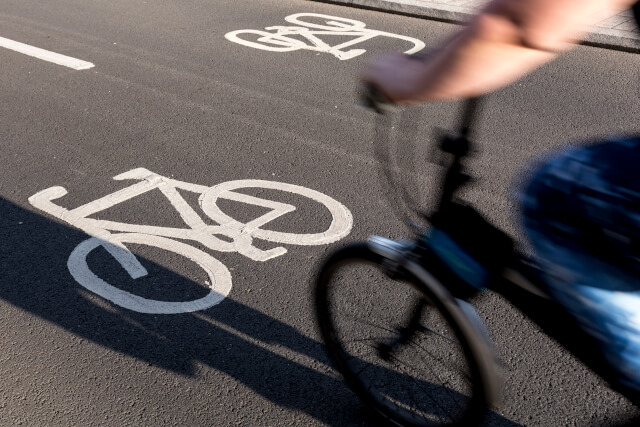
[362,0,640,392]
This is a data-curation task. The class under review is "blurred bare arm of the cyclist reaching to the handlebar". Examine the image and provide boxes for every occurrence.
[363,0,635,103]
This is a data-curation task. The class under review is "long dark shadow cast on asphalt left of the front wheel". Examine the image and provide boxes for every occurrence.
[0,198,517,426]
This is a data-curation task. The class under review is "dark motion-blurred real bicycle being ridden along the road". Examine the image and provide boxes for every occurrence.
[314,88,640,426]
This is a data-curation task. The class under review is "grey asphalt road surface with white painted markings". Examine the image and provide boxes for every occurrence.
[0,0,640,426]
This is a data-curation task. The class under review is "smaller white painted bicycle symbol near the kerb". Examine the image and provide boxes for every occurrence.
[225,13,425,60]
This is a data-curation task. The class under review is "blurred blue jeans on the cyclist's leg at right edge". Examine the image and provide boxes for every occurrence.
[521,138,640,391]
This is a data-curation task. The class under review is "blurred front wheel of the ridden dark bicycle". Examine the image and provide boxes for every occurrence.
[315,244,487,426]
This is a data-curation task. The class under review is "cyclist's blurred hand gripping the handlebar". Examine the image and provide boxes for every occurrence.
[361,53,426,104]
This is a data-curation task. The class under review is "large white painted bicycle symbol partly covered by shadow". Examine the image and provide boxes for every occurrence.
[29,168,353,314]
